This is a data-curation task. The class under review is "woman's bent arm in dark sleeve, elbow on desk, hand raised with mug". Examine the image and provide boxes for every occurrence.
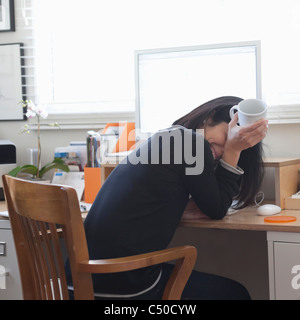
[183,115,267,219]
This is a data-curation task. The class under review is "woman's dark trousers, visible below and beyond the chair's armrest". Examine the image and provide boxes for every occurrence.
[85,263,251,300]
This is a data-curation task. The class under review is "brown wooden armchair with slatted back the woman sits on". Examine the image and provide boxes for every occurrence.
[2,175,197,300]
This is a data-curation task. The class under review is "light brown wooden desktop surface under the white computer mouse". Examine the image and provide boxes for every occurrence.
[0,201,300,232]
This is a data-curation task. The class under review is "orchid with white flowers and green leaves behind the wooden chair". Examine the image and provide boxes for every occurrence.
[8,100,69,180]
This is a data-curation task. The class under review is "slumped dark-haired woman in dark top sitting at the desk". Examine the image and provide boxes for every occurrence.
[66,97,267,299]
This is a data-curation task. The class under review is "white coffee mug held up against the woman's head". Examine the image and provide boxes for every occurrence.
[229,99,268,127]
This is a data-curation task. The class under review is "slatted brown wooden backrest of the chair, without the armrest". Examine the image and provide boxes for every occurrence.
[3,175,94,300]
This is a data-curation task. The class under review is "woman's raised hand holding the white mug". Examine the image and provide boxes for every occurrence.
[222,112,268,167]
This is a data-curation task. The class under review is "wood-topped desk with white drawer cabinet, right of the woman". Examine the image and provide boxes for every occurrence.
[180,207,300,300]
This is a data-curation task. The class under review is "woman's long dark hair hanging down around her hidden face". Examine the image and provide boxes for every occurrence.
[173,96,264,208]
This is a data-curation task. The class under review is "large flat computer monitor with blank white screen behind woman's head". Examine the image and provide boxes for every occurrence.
[135,41,261,134]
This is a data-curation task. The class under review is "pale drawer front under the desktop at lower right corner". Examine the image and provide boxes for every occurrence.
[273,242,300,300]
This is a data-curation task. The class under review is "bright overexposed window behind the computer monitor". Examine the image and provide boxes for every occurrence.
[25,0,300,120]
